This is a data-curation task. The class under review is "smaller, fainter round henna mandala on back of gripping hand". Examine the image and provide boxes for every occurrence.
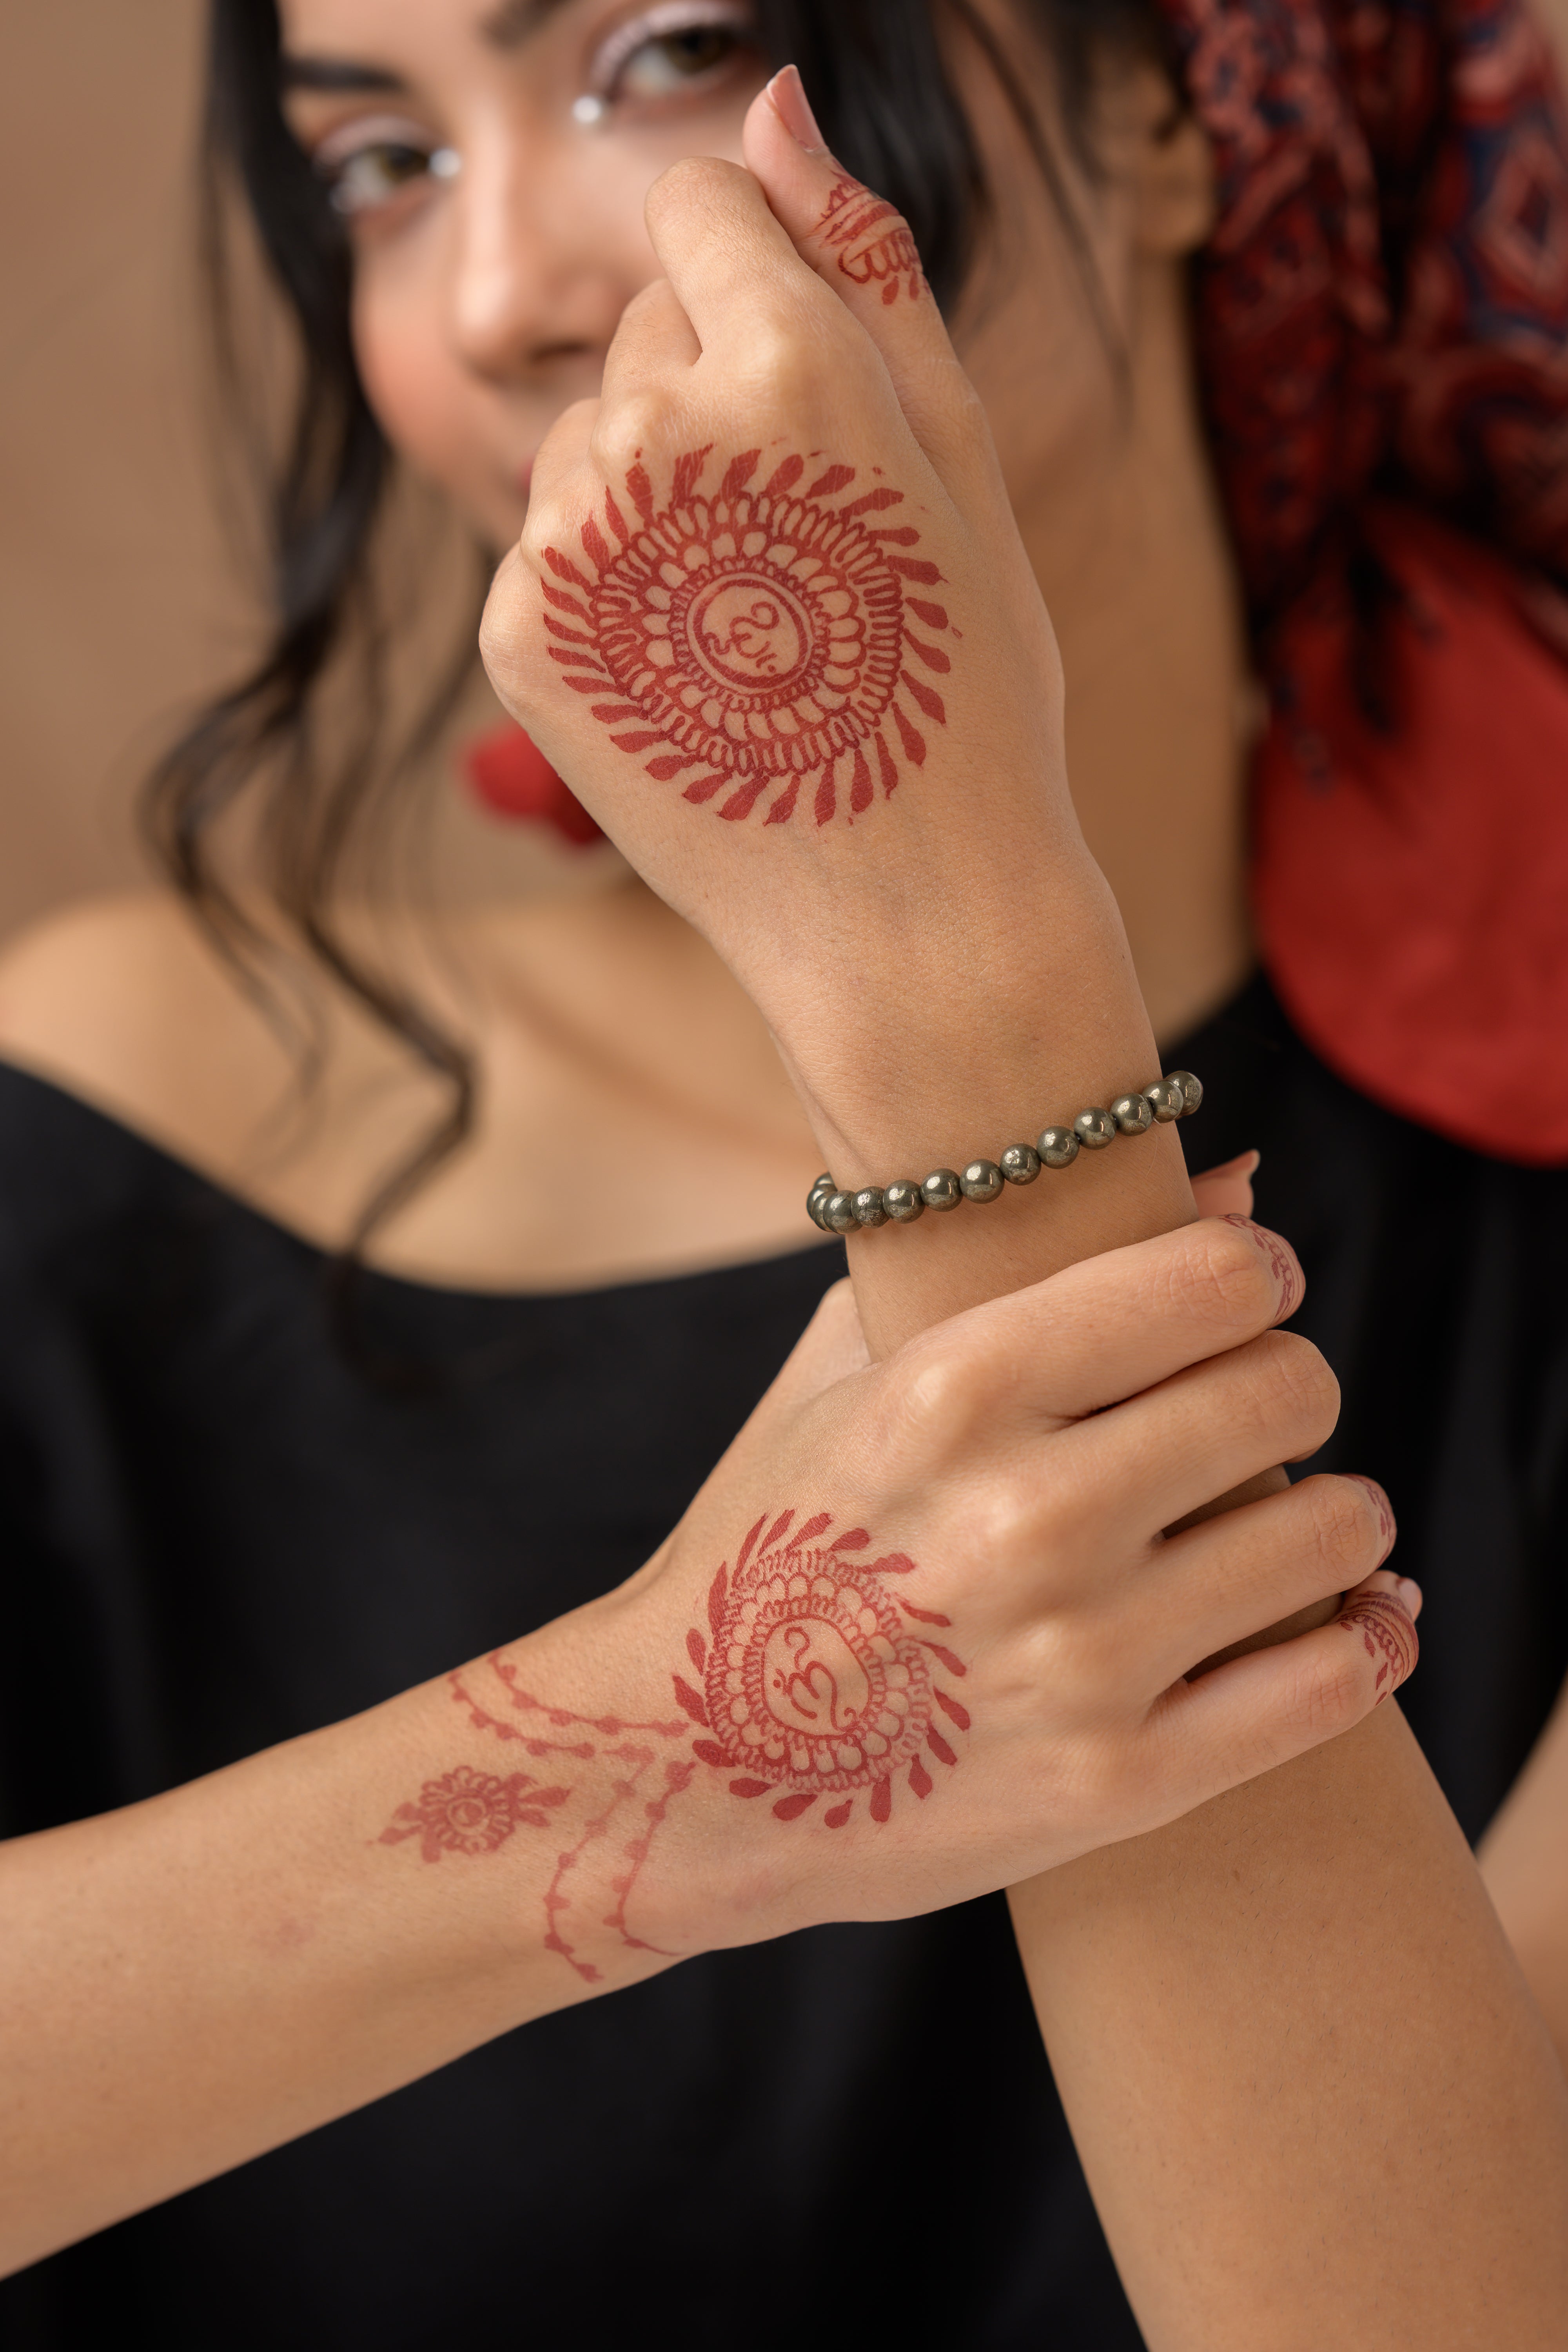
[675,1510,969,1830]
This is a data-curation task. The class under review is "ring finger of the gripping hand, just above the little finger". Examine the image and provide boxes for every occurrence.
[1128,1477,1396,1686]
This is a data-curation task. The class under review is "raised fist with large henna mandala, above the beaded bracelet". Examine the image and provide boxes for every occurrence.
[484,78,1142,1181]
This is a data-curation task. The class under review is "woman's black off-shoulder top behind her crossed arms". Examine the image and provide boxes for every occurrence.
[0,981,1568,2352]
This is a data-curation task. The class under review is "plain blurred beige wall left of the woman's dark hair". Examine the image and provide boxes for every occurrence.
[0,0,1568,934]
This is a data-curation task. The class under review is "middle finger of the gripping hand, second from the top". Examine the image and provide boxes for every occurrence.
[1042,1331,1340,1557]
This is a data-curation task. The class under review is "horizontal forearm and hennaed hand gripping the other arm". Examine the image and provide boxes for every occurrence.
[0,1204,1420,2267]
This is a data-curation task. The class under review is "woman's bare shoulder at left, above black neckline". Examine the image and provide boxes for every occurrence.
[0,891,289,1164]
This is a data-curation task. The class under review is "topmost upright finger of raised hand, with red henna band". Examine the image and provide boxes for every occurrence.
[740,66,971,454]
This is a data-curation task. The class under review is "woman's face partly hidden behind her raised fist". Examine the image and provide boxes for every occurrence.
[282,0,766,548]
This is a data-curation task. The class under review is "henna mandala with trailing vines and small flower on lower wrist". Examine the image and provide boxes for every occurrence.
[381,1510,969,1983]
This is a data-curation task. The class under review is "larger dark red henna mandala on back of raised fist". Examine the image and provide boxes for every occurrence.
[543,449,957,826]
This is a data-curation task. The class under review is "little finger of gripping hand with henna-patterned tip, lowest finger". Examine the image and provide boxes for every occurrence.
[1143,1569,1420,1804]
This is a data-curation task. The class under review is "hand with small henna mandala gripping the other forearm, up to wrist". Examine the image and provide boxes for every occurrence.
[386,1214,1420,1983]
